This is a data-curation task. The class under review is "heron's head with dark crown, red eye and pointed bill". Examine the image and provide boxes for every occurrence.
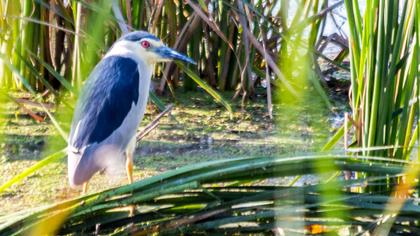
[110,31,196,64]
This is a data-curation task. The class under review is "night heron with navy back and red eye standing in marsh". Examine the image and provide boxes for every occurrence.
[67,31,196,193]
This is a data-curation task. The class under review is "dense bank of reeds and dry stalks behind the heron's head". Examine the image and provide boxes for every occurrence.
[0,0,334,102]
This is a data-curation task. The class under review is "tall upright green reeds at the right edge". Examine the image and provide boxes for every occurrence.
[345,0,419,160]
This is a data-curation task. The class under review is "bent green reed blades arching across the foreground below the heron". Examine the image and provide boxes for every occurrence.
[0,155,420,235]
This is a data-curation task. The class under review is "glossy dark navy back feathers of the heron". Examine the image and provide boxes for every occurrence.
[70,56,139,149]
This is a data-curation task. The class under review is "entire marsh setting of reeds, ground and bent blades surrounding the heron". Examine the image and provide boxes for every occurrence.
[0,0,420,235]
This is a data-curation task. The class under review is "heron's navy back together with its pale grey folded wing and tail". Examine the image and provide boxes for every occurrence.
[68,56,140,186]
